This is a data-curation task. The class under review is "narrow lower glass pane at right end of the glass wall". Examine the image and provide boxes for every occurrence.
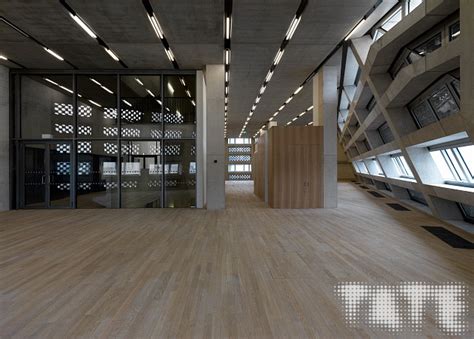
[164,140,196,207]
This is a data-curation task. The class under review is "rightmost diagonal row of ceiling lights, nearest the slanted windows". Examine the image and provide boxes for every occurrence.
[250,1,381,138]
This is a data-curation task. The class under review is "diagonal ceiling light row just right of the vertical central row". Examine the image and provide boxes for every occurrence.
[239,0,308,138]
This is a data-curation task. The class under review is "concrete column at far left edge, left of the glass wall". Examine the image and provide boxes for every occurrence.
[0,65,10,211]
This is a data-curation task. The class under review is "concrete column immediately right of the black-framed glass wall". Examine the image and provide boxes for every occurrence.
[204,65,225,209]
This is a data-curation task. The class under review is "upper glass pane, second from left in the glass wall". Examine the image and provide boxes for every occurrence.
[77,75,118,139]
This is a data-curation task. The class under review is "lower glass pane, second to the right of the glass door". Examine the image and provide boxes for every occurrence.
[121,140,162,208]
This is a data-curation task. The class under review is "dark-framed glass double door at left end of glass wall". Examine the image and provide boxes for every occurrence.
[21,142,72,208]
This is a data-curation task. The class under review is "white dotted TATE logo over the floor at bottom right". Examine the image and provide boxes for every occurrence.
[334,282,468,335]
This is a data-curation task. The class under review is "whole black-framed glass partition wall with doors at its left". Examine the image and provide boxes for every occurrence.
[12,71,197,208]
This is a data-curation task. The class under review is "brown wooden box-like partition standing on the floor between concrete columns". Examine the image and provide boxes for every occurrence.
[254,126,324,208]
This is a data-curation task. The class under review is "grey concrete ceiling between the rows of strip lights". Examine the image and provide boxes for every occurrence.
[0,0,377,136]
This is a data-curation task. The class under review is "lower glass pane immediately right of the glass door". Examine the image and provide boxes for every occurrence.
[77,140,119,208]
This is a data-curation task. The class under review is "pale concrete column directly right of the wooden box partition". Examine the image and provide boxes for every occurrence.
[313,66,337,208]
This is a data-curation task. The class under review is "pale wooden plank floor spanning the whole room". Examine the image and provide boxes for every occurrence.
[0,183,474,338]
